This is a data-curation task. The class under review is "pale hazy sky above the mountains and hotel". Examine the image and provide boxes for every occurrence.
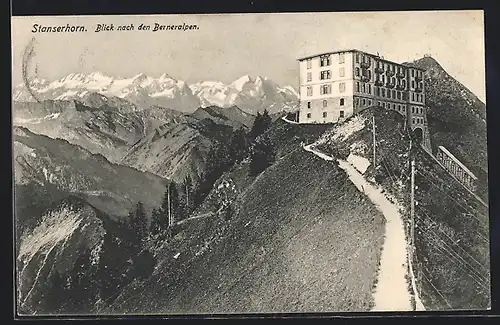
[12,11,485,101]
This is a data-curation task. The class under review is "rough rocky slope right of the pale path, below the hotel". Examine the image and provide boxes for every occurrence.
[319,107,490,310]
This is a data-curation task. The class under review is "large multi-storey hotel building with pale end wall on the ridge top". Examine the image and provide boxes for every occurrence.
[298,49,427,133]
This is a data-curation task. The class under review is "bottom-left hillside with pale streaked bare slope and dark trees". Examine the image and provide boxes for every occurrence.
[16,195,155,315]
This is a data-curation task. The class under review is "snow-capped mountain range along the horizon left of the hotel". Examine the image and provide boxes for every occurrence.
[13,72,298,113]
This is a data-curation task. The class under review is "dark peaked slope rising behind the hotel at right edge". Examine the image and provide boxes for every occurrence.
[407,57,488,199]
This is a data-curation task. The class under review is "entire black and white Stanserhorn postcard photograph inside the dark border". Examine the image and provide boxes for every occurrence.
[11,10,491,316]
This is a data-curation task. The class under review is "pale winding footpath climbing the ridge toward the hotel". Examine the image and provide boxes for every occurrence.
[303,145,425,311]
